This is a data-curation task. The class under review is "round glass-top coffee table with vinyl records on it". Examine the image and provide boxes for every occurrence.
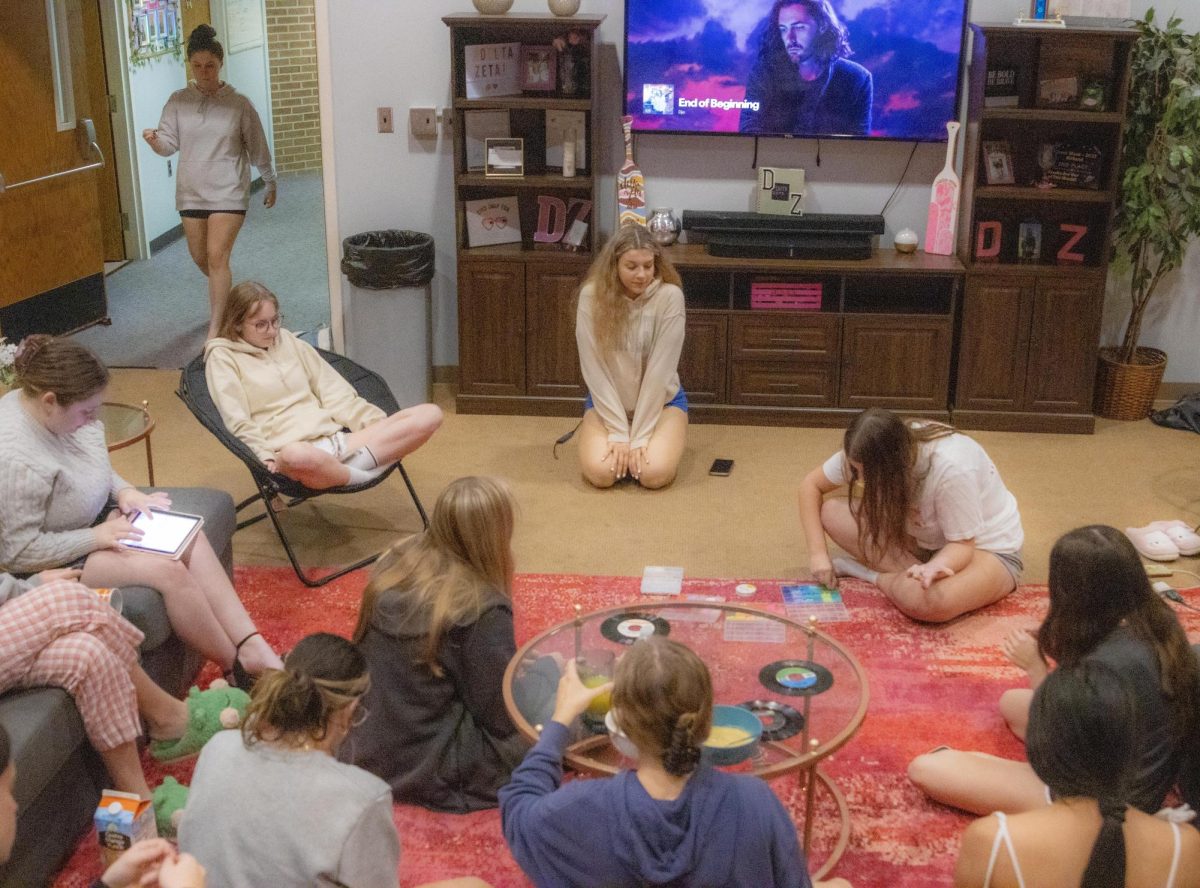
[504,600,869,878]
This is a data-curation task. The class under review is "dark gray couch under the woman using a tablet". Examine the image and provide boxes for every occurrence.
[0,488,236,888]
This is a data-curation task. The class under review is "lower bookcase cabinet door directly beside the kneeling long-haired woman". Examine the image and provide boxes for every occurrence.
[526,263,587,397]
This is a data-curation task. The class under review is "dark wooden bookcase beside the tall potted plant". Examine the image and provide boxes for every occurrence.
[953,25,1136,433]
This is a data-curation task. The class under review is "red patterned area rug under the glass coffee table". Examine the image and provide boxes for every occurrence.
[55,568,1200,888]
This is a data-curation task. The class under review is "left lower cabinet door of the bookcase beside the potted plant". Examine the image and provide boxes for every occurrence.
[954,277,1032,410]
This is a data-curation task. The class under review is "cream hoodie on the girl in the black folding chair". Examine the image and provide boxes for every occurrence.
[204,330,386,462]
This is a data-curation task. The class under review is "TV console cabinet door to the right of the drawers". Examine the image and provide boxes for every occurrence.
[838,314,950,410]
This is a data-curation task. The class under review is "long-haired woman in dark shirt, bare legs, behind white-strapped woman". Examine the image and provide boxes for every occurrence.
[908,524,1200,814]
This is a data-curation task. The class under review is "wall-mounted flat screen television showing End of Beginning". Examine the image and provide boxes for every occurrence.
[625,0,966,142]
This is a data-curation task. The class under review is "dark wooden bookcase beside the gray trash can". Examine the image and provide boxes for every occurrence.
[442,14,604,415]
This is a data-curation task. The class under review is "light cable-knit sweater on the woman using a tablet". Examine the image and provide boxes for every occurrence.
[0,391,131,574]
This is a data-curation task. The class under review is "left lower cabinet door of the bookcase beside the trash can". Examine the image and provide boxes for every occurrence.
[458,262,526,395]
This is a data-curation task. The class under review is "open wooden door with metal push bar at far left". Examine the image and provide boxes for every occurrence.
[0,0,108,340]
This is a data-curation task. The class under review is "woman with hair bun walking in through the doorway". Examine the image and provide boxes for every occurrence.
[142,25,276,338]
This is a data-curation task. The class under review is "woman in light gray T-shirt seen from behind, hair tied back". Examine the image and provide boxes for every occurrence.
[179,632,486,888]
